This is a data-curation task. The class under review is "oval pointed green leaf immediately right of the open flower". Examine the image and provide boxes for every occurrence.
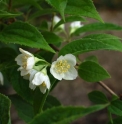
[78,61,110,82]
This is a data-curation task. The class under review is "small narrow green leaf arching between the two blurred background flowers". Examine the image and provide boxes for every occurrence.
[54,16,86,29]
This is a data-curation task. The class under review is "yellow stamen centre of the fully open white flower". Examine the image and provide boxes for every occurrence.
[55,60,70,74]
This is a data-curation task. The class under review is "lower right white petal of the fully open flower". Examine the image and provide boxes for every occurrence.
[63,66,78,80]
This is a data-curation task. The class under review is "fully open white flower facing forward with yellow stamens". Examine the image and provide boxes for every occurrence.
[50,54,78,80]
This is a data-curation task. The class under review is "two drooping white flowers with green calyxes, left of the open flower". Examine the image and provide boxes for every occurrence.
[15,48,50,93]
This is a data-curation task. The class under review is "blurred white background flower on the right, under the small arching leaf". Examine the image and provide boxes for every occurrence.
[70,21,83,34]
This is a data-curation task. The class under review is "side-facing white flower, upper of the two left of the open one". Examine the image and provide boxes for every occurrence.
[15,48,35,76]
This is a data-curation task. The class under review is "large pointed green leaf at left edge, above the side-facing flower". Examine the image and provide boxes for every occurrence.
[0,22,54,52]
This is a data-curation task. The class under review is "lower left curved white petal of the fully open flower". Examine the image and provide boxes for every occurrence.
[50,61,62,80]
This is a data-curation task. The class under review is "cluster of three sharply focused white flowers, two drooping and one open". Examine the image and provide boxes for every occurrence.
[15,48,78,94]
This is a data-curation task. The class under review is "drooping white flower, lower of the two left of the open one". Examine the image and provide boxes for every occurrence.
[29,69,50,94]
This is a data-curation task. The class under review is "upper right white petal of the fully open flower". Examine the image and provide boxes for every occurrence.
[64,54,76,66]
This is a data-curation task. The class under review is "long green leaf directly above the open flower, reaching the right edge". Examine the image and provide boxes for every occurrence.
[59,34,122,55]
